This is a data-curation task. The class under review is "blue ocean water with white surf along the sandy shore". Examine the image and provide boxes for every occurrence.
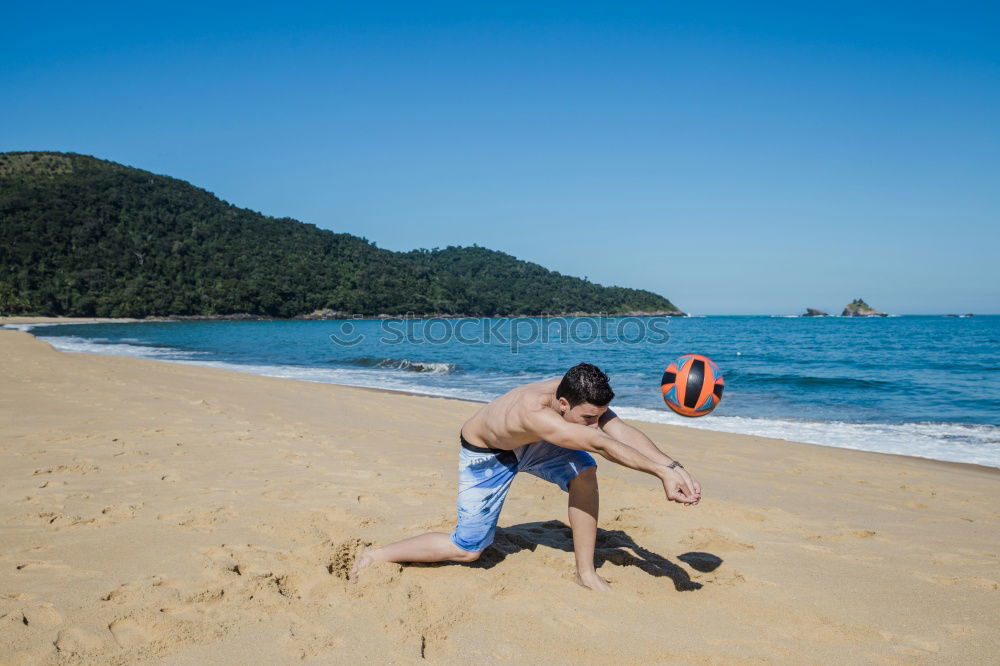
[13,315,1000,467]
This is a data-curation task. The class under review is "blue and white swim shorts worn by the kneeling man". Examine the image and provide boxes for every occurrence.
[451,430,597,552]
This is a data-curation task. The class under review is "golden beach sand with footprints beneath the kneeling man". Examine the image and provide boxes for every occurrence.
[0,331,1000,665]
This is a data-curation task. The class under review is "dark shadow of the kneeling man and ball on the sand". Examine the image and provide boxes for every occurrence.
[409,520,722,591]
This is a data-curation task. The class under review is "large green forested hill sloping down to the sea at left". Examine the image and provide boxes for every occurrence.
[0,153,677,317]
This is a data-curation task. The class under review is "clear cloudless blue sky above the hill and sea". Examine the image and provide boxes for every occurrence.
[0,2,1000,313]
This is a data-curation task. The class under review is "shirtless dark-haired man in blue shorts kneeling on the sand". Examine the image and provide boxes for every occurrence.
[351,363,701,590]
